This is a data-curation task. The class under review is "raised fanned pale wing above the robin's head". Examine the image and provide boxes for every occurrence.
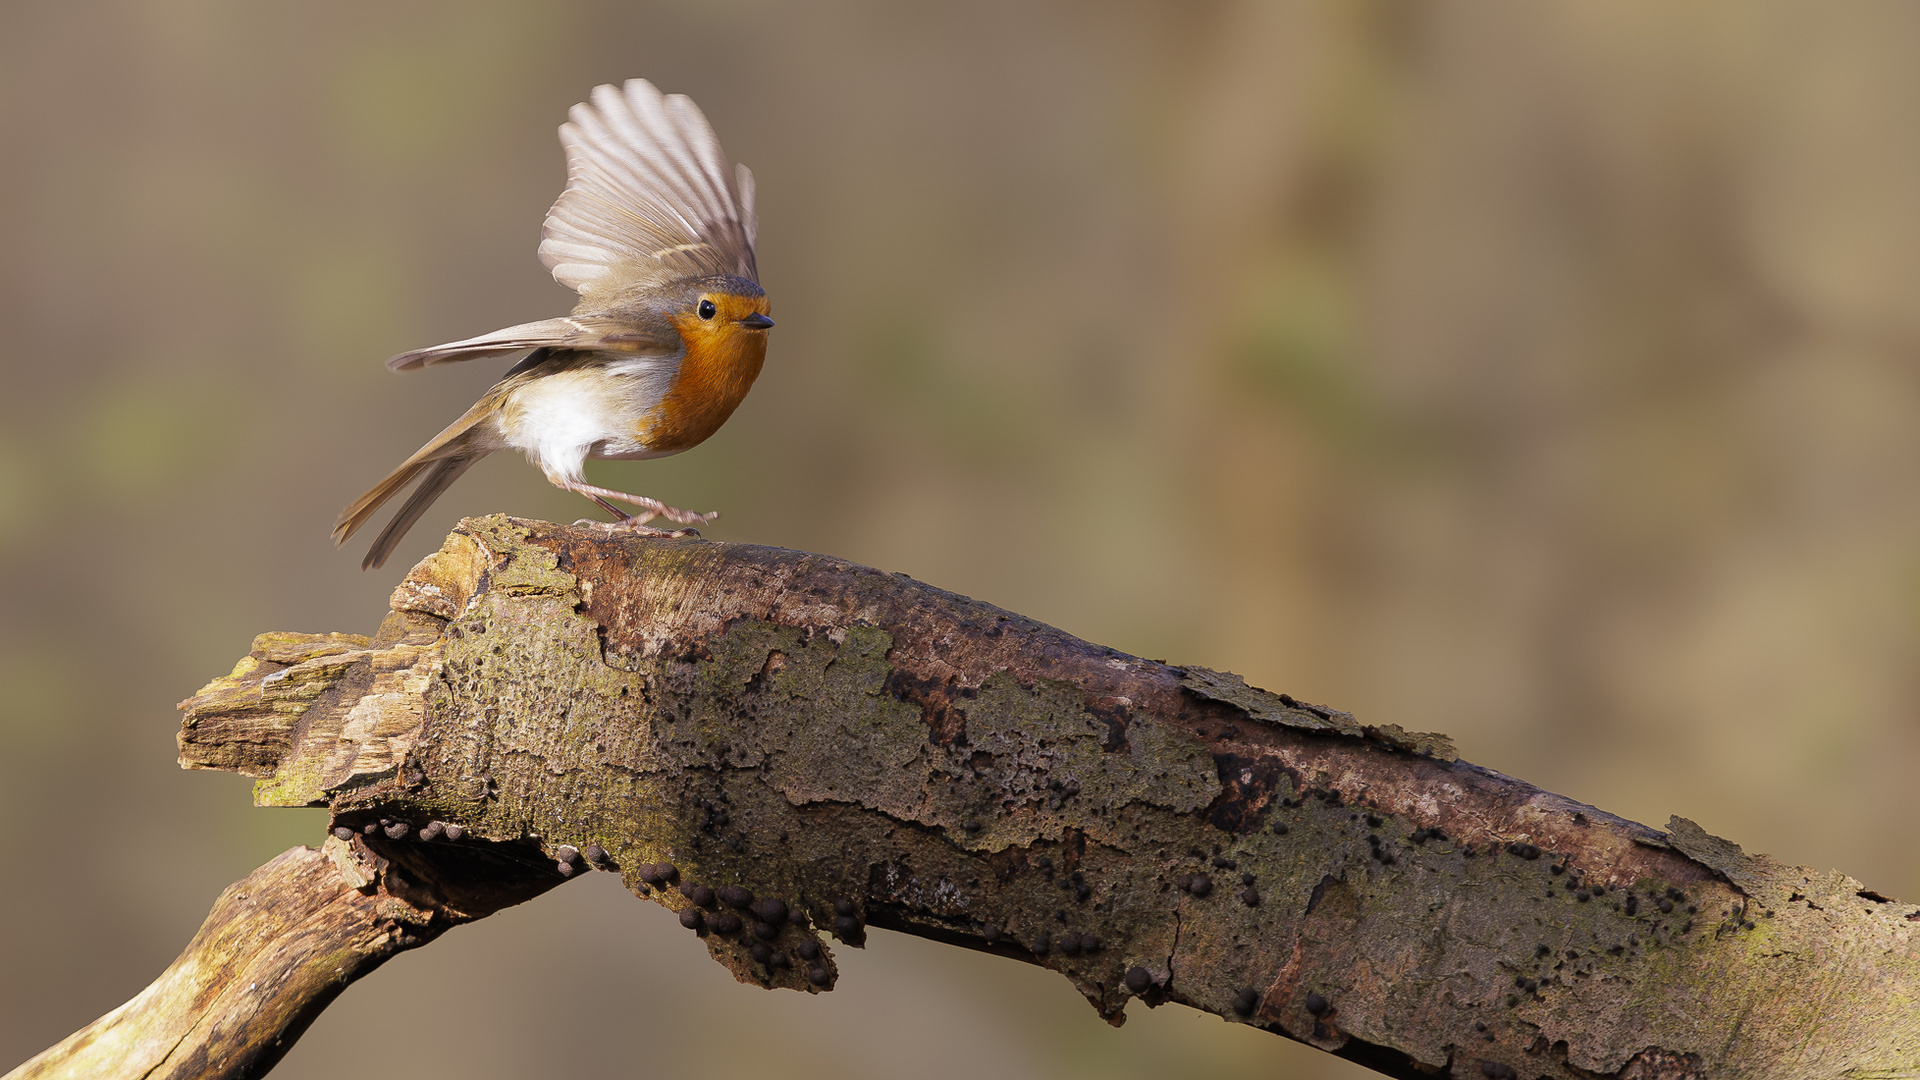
[540,79,758,298]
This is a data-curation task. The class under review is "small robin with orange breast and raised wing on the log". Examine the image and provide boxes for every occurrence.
[334,79,774,569]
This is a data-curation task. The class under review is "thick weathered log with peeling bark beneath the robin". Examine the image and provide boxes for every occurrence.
[25,517,1920,1078]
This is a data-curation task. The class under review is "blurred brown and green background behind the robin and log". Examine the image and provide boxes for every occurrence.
[0,0,1920,1080]
